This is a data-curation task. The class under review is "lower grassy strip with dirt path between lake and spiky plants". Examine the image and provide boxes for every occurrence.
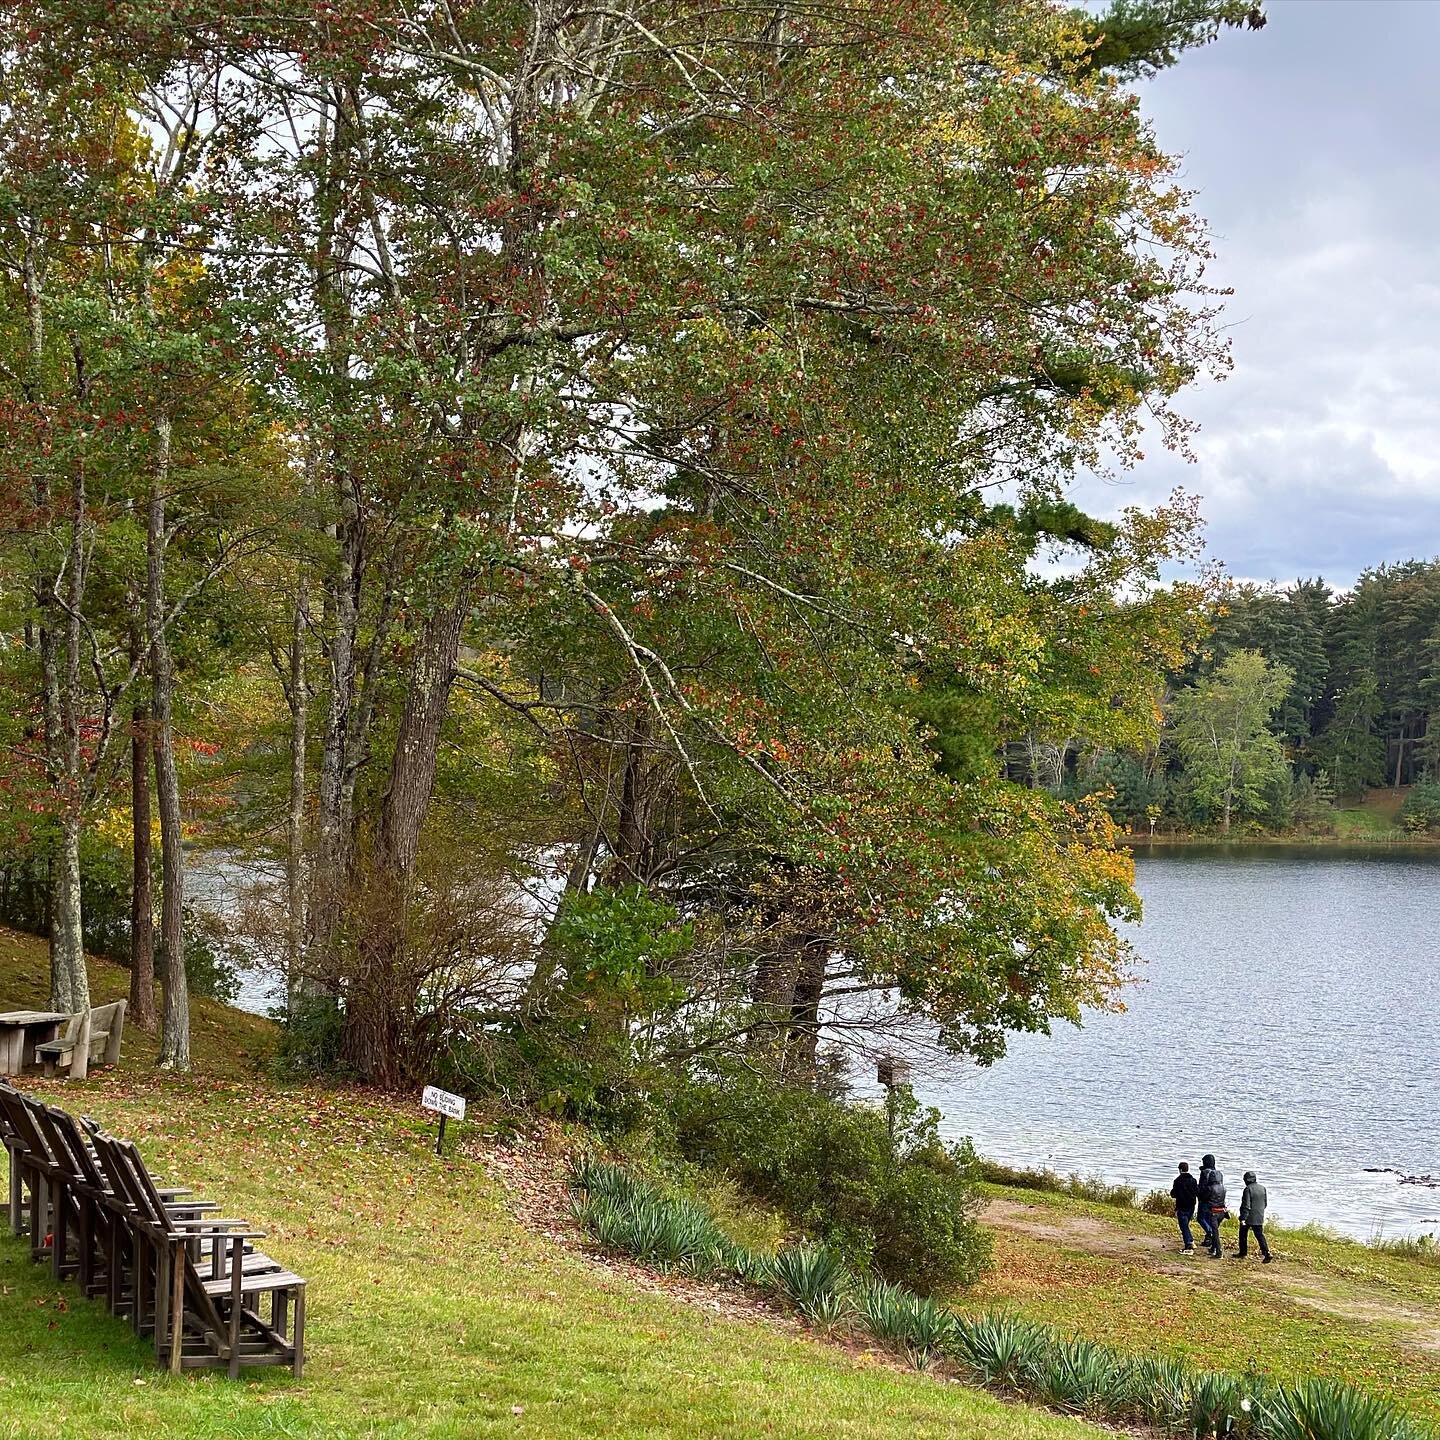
[966,1187,1440,1416]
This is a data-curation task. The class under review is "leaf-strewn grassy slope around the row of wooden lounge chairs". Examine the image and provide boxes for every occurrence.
[0,932,1100,1440]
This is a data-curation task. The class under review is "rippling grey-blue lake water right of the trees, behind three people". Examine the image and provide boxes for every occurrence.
[916,847,1440,1238]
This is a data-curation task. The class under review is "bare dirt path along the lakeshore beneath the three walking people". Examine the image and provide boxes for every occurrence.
[985,1200,1440,1354]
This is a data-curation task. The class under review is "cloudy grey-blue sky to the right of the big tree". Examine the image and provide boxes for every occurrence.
[1077,0,1440,585]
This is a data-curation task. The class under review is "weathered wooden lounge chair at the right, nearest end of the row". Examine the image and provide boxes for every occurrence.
[92,1132,305,1378]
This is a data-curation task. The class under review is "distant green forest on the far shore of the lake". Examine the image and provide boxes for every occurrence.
[1031,560,1440,832]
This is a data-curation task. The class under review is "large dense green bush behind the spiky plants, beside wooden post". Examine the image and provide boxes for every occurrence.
[670,1074,991,1295]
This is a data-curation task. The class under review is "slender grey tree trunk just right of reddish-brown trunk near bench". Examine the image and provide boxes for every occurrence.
[145,410,190,1070]
